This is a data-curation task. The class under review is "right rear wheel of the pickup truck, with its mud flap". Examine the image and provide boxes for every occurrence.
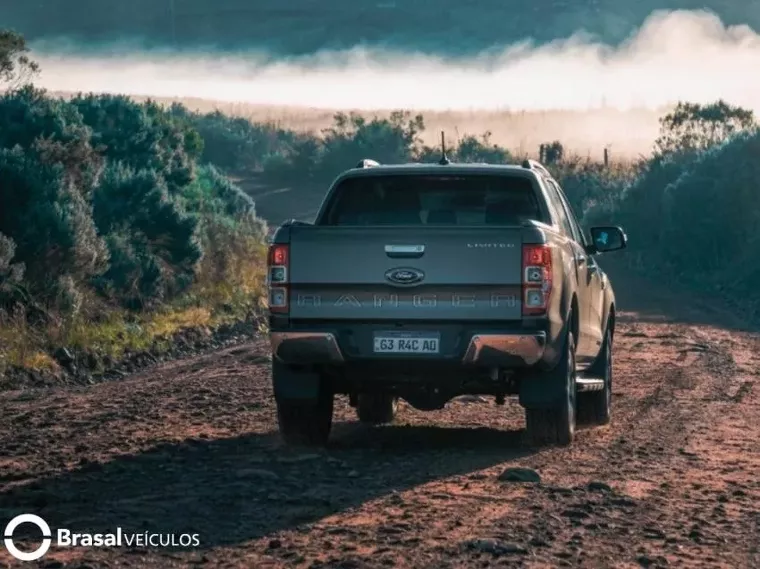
[525,332,577,446]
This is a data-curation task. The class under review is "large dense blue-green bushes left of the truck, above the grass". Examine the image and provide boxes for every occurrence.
[0,80,266,317]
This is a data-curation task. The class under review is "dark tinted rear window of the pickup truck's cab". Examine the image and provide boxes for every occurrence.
[322,175,547,226]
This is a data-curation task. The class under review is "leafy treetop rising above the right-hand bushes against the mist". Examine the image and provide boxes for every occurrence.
[655,100,756,157]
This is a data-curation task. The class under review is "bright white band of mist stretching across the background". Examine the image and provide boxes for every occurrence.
[23,11,760,110]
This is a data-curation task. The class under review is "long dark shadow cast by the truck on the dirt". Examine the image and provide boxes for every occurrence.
[0,423,530,549]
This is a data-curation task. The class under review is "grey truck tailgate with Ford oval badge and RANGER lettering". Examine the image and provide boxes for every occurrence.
[289,226,522,321]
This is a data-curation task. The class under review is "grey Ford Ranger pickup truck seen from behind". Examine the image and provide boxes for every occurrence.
[267,157,627,445]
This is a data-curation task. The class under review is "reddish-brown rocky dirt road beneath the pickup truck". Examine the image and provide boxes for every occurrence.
[0,264,760,569]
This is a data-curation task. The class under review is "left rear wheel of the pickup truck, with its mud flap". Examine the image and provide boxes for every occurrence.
[277,391,334,446]
